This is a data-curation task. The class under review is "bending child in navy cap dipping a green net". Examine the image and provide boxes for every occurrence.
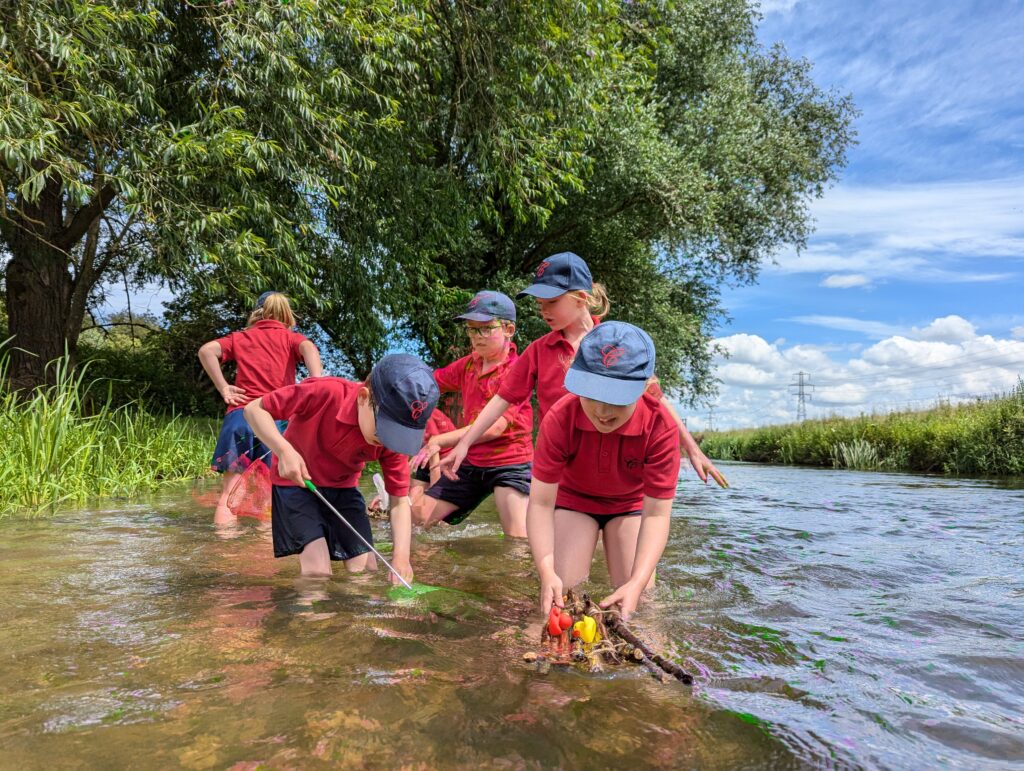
[245,353,439,581]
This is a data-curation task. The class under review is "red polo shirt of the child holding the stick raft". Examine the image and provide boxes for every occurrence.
[534,394,679,514]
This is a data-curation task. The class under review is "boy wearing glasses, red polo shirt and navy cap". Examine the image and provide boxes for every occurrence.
[413,292,534,538]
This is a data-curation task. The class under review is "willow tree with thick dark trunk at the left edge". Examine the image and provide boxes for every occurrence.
[0,0,418,386]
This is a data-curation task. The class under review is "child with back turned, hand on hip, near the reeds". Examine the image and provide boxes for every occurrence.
[193,292,323,524]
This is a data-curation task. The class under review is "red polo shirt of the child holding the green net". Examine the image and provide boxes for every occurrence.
[262,378,409,496]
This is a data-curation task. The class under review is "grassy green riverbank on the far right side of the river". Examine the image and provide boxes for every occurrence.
[700,385,1024,476]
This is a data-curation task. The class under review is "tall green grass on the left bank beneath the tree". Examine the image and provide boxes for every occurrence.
[0,357,217,518]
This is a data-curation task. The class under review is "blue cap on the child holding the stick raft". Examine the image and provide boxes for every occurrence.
[565,322,654,405]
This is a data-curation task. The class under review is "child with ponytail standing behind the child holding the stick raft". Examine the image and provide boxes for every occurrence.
[442,252,729,487]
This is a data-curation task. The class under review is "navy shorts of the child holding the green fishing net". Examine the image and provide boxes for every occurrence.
[270,484,374,560]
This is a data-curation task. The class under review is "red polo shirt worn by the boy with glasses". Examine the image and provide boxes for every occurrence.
[434,346,532,468]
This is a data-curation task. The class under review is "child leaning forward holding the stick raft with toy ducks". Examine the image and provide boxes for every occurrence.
[526,322,680,618]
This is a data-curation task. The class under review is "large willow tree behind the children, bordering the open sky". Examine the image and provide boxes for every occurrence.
[322,0,855,401]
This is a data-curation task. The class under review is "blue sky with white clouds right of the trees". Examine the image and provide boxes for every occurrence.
[689,0,1024,428]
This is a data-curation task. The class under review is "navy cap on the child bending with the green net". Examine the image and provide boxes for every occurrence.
[370,353,441,455]
